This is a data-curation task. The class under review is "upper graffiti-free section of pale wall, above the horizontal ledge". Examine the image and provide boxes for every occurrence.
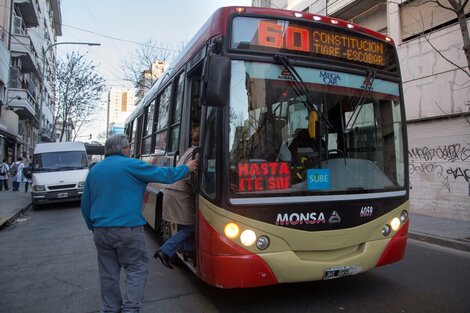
[398,21,470,120]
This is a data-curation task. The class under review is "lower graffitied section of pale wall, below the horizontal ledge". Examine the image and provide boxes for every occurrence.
[408,116,470,221]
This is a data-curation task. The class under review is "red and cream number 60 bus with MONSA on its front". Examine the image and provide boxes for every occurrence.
[126,7,409,288]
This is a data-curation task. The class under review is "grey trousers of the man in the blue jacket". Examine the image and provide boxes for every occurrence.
[93,226,149,313]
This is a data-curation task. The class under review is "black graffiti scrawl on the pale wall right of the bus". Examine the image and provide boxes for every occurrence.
[408,143,470,196]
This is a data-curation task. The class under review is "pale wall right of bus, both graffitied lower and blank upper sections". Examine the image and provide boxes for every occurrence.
[397,20,470,221]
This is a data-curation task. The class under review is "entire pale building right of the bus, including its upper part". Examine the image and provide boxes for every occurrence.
[252,0,470,221]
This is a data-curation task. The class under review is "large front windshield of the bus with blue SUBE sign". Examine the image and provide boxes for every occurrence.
[229,60,405,196]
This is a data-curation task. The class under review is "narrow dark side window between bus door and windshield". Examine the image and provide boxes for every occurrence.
[201,107,217,199]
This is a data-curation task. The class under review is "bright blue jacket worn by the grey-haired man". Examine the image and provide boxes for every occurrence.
[81,155,189,230]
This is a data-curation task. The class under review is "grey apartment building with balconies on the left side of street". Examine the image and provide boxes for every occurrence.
[0,0,62,161]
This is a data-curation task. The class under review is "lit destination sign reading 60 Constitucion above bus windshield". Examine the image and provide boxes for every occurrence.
[232,18,391,68]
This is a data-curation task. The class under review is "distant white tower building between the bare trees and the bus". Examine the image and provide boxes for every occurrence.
[106,87,135,136]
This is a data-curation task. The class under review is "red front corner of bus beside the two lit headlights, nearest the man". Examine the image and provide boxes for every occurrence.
[198,213,278,288]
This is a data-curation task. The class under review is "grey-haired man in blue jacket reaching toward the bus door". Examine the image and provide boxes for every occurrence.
[81,135,197,312]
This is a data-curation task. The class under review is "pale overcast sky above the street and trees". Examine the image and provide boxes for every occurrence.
[57,0,251,141]
